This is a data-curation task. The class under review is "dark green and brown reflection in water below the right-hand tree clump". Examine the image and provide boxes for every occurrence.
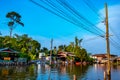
[52,65,89,80]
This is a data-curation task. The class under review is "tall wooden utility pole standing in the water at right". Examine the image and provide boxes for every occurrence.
[105,3,111,80]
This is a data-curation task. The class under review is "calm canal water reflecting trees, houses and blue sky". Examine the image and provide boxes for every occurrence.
[0,64,120,80]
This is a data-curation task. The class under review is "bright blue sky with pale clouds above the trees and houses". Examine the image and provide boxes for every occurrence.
[0,0,120,55]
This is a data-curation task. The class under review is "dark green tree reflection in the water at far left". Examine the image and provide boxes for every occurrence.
[0,65,37,80]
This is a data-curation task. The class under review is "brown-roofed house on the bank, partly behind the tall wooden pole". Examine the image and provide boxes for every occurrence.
[91,54,117,63]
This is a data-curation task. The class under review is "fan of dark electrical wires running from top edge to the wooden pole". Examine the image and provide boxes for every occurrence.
[30,0,120,55]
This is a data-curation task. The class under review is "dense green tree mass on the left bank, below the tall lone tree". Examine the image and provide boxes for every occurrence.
[0,34,41,60]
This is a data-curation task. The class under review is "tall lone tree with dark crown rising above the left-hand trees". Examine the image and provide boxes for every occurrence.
[6,11,24,37]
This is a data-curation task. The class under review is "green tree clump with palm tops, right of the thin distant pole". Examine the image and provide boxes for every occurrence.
[43,37,93,63]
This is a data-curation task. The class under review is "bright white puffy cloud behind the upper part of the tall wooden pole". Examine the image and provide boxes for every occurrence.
[97,5,120,41]
